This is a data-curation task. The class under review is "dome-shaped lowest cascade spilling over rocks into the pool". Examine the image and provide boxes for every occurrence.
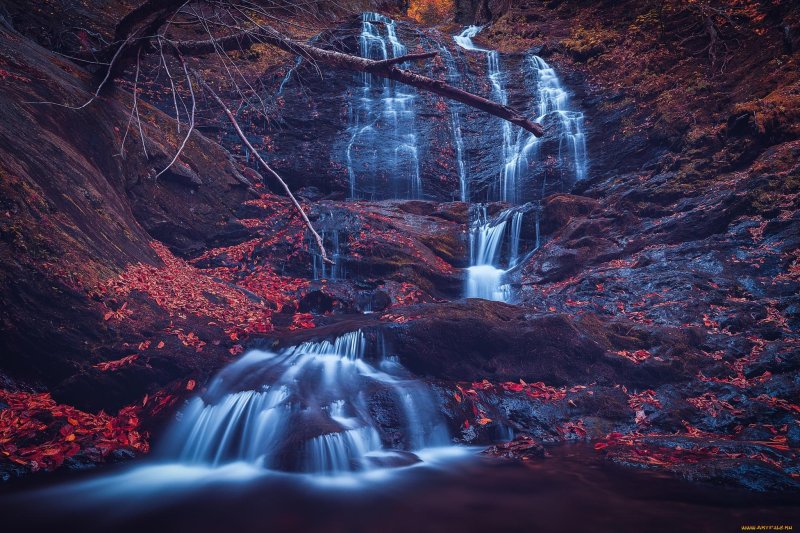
[164,330,450,474]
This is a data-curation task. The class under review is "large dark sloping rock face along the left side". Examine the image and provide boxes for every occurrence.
[0,25,248,386]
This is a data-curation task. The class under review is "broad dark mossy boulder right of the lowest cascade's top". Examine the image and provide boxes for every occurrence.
[385,299,606,384]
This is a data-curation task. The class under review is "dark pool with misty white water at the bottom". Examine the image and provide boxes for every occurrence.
[0,444,800,533]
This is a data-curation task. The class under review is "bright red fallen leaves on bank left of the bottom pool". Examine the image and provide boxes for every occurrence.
[0,390,149,471]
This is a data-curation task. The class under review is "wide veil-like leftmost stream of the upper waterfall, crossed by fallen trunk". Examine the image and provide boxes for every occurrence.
[345,13,422,199]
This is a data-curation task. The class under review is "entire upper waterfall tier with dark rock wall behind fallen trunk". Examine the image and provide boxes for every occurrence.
[262,13,588,204]
